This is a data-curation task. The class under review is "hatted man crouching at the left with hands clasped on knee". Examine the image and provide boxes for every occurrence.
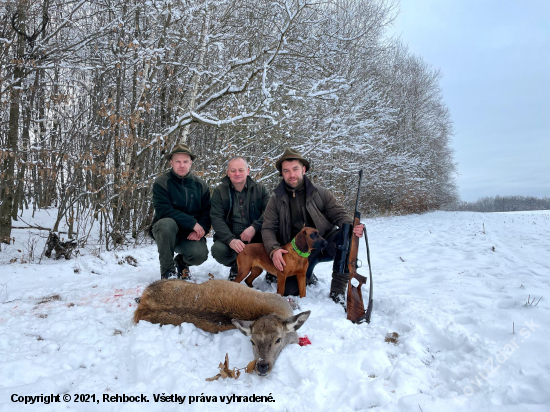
[151,144,210,279]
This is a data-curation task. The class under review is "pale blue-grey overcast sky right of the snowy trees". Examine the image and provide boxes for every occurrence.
[392,0,550,201]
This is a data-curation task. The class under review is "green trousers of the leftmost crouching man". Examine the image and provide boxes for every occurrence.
[153,217,208,276]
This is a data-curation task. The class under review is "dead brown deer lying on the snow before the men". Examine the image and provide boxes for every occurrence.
[134,279,310,376]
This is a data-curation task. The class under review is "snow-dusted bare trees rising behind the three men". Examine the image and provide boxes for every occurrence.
[0,0,457,247]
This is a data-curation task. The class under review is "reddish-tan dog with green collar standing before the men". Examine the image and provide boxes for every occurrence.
[235,227,327,298]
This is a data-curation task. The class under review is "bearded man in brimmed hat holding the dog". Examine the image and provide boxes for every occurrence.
[262,148,363,302]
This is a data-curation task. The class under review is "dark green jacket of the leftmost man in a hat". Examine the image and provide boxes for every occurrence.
[153,170,210,238]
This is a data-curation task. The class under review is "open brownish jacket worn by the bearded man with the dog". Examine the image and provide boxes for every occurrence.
[262,176,353,256]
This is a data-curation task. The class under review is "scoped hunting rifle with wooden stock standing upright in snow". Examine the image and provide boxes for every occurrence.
[347,170,372,323]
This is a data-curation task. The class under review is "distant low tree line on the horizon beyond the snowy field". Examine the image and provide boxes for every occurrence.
[449,196,550,212]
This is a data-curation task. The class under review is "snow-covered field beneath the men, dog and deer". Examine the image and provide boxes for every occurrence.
[0,211,550,412]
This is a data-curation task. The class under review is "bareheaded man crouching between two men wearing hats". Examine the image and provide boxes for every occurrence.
[210,157,269,280]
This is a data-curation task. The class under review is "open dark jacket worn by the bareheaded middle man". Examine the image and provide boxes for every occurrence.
[210,176,269,245]
